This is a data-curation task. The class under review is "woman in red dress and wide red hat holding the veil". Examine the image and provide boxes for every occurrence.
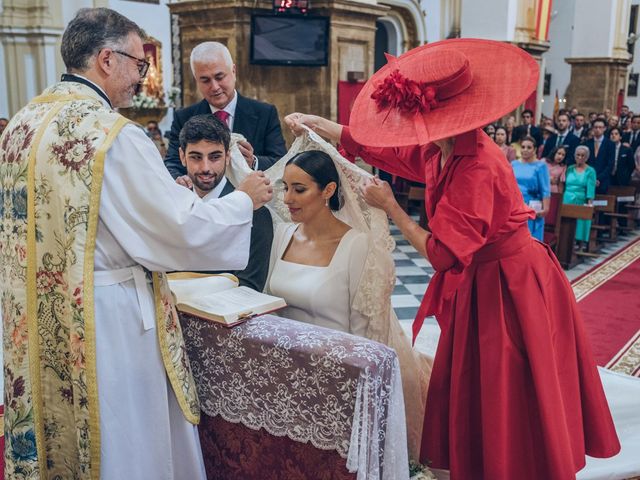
[285,39,620,480]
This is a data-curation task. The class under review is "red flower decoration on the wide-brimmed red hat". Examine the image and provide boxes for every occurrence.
[371,70,438,113]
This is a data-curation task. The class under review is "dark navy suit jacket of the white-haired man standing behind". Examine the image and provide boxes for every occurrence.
[164,92,287,178]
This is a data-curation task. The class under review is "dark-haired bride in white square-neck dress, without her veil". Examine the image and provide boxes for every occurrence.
[266,150,369,337]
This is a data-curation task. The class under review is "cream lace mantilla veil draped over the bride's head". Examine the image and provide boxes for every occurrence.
[226,129,432,460]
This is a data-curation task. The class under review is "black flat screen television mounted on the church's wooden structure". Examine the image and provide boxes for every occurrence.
[251,15,329,66]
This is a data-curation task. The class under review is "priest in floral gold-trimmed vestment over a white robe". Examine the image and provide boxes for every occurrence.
[0,8,272,479]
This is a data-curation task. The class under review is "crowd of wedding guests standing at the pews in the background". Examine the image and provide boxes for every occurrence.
[484,105,640,250]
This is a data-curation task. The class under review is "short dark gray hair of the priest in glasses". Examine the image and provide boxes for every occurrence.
[60,8,147,73]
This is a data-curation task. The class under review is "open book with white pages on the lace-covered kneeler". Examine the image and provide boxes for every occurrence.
[168,272,287,326]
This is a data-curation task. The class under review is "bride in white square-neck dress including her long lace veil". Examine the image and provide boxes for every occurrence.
[227,131,432,460]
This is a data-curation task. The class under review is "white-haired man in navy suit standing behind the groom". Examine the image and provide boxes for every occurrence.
[165,42,287,180]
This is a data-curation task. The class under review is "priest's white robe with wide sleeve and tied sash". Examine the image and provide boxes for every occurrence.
[95,120,253,480]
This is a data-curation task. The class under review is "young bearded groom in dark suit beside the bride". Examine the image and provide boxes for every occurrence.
[176,114,273,292]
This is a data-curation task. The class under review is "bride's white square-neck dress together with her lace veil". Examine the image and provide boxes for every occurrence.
[226,127,433,460]
